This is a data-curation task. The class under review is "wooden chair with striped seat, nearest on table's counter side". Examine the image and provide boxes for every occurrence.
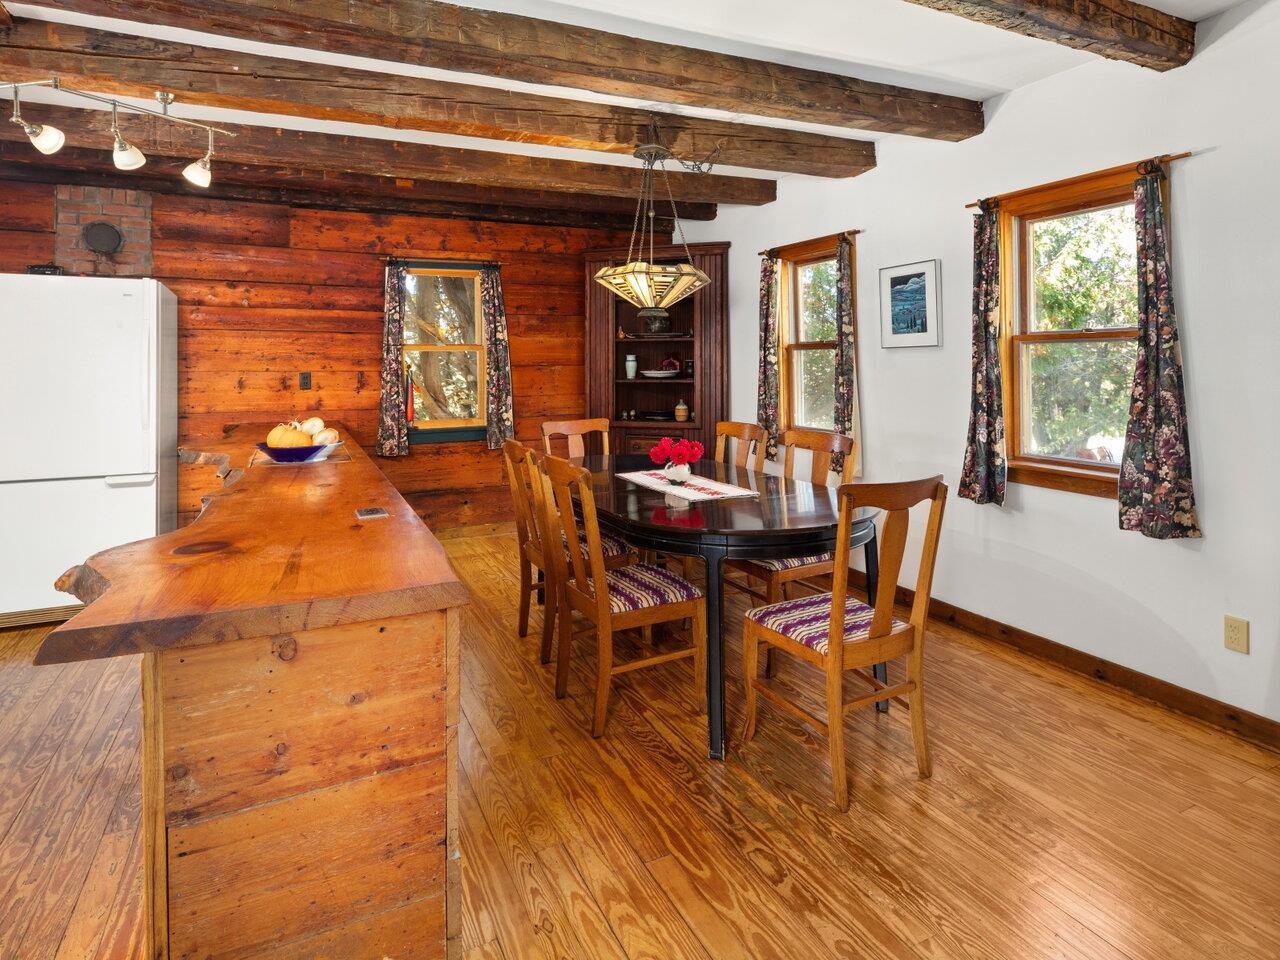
[539,457,707,737]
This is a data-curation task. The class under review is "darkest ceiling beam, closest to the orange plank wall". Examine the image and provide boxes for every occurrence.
[0,141,716,232]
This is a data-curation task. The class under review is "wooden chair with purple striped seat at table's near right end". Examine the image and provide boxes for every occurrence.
[742,476,947,810]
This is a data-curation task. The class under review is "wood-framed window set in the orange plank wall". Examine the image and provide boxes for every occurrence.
[404,268,485,440]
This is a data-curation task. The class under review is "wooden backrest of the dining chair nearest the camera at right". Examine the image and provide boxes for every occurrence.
[828,475,947,650]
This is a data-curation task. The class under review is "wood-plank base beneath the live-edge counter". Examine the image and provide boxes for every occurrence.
[142,609,460,960]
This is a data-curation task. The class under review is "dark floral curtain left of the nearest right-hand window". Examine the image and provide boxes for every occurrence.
[959,201,1005,504]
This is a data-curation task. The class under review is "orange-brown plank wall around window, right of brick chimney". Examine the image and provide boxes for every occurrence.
[152,195,640,529]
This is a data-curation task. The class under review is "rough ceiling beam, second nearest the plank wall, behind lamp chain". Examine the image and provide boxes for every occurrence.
[0,101,777,205]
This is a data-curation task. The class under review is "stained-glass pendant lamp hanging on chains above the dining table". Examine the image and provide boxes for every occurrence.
[595,123,714,333]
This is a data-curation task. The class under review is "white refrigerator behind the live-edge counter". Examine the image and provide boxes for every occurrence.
[0,274,178,625]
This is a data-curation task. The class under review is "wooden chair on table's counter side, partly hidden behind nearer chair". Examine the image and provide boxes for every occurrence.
[502,440,636,663]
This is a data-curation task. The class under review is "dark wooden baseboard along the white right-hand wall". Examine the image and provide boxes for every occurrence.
[849,570,1280,751]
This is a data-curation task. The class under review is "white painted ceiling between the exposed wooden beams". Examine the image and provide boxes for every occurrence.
[0,0,1239,177]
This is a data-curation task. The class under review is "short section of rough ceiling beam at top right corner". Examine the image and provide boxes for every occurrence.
[909,0,1196,70]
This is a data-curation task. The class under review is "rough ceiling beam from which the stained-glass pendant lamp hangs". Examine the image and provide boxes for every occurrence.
[0,19,876,177]
